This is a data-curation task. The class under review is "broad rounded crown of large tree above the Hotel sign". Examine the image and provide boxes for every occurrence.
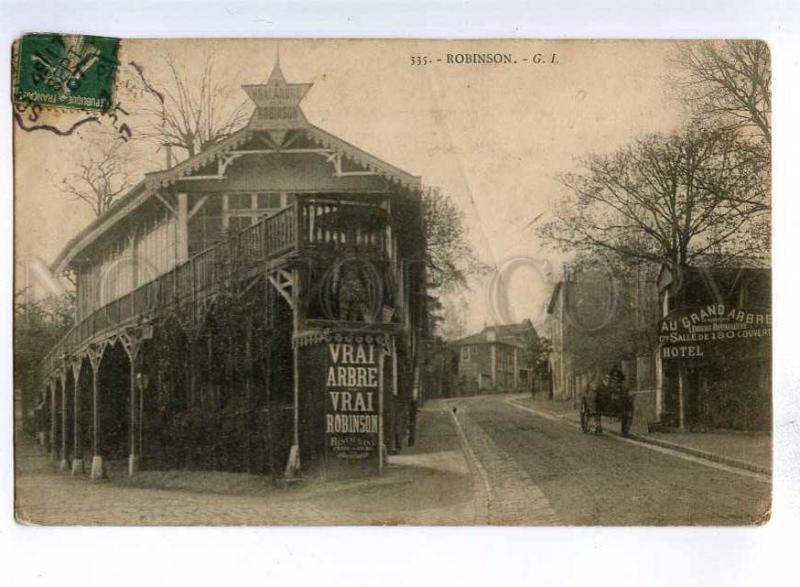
[538,130,769,266]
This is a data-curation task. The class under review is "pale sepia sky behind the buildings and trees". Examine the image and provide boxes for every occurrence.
[15,39,682,332]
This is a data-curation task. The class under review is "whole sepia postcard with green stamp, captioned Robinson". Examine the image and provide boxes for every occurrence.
[11,33,772,526]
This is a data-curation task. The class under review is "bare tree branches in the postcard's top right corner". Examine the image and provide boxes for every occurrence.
[675,40,772,153]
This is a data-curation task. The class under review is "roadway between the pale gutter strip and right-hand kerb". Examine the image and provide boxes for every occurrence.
[449,395,771,526]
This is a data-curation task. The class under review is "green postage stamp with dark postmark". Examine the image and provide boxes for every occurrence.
[14,33,119,112]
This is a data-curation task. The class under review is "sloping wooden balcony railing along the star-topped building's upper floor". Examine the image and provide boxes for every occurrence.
[42,197,388,373]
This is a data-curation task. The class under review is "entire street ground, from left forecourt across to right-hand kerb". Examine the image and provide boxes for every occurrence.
[17,396,770,525]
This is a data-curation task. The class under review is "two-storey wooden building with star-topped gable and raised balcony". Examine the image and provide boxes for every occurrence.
[41,64,425,478]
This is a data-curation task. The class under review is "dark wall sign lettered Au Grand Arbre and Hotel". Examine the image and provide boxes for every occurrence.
[658,304,772,359]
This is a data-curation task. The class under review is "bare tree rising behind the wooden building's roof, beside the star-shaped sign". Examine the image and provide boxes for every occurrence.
[129,56,250,162]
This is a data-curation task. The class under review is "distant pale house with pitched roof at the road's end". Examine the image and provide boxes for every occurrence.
[450,320,538,395]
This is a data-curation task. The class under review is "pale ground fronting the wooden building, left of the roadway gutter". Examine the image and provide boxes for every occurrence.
[16,410,477,525]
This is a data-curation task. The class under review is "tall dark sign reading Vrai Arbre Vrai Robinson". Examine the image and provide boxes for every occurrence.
[325,342,382,474]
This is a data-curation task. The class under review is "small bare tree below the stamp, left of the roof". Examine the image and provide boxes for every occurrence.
[58,134,131,216]
